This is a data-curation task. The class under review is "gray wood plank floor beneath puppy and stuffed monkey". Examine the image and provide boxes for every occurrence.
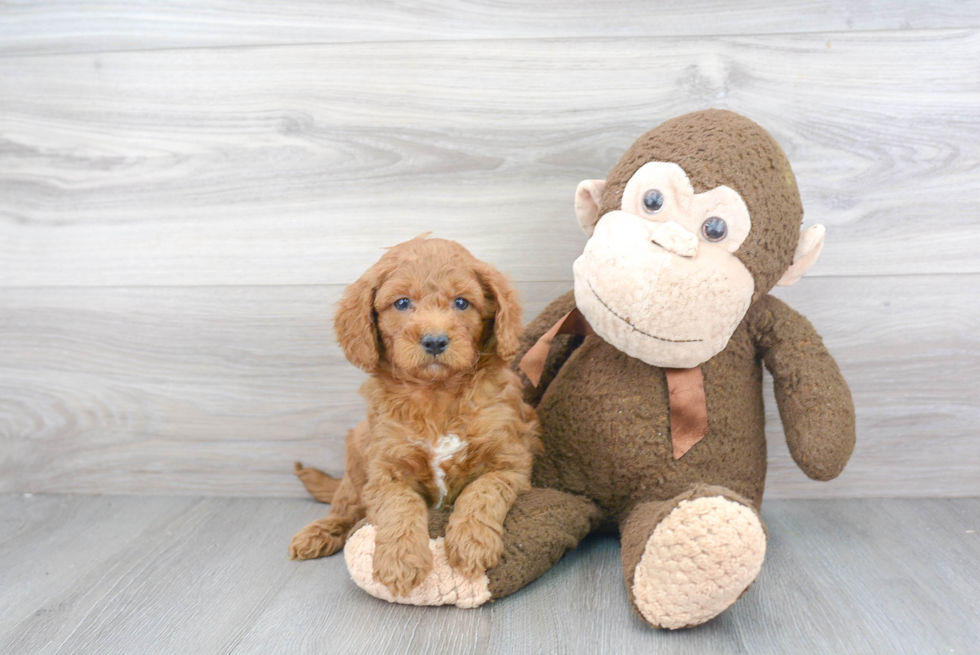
[0,494,980,655]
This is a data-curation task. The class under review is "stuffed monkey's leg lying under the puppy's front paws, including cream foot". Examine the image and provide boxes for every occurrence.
[344,489,602,608]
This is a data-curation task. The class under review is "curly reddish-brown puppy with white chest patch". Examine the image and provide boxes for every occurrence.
[289,236,540,596]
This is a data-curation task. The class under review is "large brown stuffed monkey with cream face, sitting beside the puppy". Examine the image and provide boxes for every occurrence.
[338,110,854,628]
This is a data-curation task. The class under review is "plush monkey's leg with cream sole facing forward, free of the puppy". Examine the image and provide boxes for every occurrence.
[620,486,766,630]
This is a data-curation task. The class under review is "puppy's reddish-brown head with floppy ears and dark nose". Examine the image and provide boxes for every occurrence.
[334,237,521,380]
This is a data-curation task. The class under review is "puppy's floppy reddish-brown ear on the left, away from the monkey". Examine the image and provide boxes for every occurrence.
[333,258,393,373]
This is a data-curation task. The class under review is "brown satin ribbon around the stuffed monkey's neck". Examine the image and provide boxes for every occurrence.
[519,308,708,459]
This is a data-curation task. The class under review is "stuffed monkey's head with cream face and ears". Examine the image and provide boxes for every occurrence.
[574,110,824,368]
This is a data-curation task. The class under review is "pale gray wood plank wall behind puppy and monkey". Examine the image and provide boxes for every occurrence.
[0,0,980,497]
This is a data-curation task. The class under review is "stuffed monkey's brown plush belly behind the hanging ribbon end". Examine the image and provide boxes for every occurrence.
[535,337,766,515]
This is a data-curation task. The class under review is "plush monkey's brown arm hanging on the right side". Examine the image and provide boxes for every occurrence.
[748,296,854,480]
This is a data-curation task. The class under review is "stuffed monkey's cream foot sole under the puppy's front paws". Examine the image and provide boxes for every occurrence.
[344,523,498,609]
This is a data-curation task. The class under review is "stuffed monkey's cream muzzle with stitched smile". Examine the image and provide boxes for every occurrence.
[573,211,755,368]
